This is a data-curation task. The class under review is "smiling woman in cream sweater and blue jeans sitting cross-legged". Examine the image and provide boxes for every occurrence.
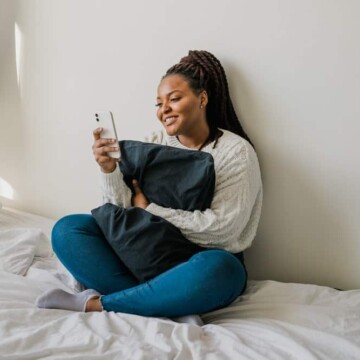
[37,51,262,317]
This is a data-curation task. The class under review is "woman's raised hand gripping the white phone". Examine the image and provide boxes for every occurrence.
[92,128,119,174]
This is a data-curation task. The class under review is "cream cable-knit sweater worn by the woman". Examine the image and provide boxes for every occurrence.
[101,130,262,253]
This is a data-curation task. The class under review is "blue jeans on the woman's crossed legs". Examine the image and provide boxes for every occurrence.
[52,214,247,317]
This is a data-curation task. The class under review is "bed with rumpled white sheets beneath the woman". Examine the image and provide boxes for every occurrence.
[0,208,360,360]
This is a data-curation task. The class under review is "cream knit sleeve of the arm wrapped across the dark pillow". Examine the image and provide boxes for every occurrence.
[146,142,261,252]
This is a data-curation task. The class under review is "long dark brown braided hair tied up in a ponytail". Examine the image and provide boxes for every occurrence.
[163,50,253,147]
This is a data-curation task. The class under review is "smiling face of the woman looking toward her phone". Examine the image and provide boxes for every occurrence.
[156,75,207,136]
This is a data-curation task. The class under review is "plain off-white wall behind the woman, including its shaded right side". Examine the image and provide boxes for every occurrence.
[0,0,360,288]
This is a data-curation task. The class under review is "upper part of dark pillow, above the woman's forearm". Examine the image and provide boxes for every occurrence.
[119,140,215,211]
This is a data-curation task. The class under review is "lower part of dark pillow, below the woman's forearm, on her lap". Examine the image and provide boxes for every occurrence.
[92,203,204,283]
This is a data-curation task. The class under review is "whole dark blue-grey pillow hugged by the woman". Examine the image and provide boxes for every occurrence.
[92,141,215,283]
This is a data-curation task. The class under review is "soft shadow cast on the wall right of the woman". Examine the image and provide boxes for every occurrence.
[224,59,356,288]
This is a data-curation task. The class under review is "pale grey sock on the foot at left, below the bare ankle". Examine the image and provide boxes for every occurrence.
[36,289,101,312]
